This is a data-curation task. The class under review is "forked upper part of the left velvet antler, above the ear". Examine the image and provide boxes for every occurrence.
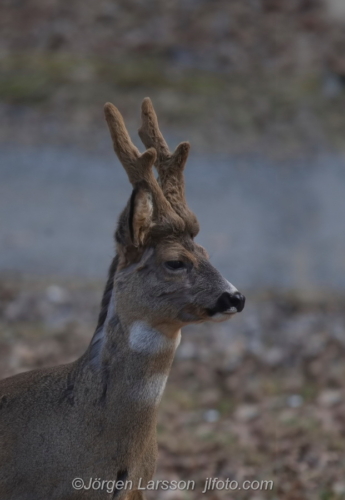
[104,102,157,186]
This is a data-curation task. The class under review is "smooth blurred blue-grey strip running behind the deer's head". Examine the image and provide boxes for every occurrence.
[0,146,345,290]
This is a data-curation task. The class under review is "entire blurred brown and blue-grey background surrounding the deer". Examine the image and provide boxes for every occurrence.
[0,0,345,500]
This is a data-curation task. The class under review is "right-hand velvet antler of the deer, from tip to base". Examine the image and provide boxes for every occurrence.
[138,97,199,234]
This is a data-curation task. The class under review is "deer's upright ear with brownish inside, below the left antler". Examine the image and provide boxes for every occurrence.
[129,188,153,247]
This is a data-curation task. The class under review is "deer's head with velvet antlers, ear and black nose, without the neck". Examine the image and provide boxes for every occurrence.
[105,98,245,332]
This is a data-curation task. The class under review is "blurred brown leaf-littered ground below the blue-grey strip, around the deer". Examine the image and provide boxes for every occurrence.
[0,277,345,500]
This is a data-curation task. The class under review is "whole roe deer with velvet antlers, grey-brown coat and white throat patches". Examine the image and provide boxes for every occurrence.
[0,98,245,500]
